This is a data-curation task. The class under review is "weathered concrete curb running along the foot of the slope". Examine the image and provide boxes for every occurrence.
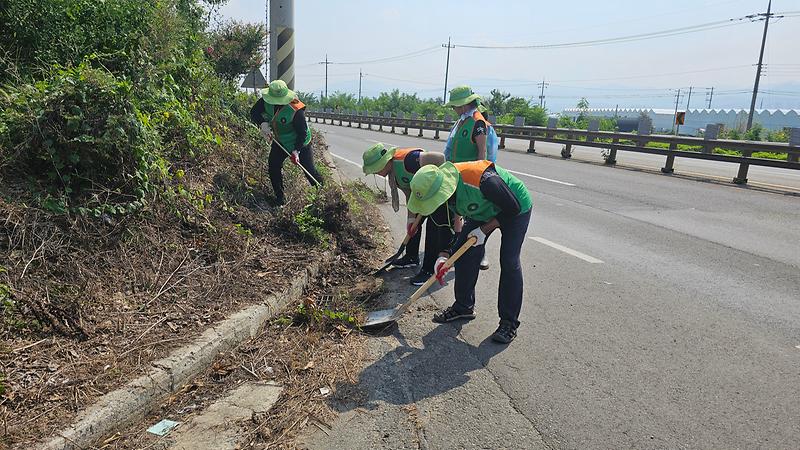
[39,241,333,450]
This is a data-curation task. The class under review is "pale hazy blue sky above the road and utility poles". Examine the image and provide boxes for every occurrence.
[216,0,800,111]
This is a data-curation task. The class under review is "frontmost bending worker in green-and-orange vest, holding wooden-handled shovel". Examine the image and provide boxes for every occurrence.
[408,160,533,344]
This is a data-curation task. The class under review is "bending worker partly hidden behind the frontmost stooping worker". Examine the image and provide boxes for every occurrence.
[362,142,453,286]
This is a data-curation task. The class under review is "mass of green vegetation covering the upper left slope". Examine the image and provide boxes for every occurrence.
[0,0,264,217]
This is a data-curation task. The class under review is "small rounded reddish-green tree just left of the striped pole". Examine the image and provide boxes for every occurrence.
[207,21,267,80]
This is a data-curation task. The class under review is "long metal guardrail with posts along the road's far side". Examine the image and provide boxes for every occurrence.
[306,110,800,184]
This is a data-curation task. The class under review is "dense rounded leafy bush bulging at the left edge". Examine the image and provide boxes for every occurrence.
[0,64,163,215]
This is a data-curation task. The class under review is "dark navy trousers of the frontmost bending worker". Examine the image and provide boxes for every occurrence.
[454,211,531,327]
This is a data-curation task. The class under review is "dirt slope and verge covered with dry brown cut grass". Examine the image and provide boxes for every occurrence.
[0,132,388,448]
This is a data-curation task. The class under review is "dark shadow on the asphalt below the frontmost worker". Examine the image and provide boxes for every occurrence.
[331,323,507,412]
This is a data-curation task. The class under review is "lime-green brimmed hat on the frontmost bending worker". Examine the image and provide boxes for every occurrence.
[407,162,458,216]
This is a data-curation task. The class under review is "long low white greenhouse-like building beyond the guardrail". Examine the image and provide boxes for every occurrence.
[563,108,800,135]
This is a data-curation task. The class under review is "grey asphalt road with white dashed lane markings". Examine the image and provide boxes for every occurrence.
[307,124,800,449]
